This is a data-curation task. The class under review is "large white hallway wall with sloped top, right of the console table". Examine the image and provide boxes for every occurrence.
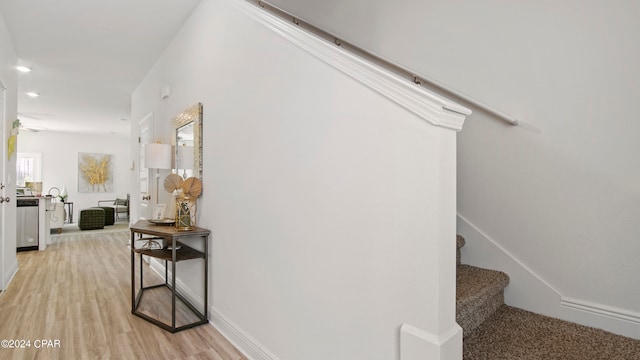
[131,0,466,360]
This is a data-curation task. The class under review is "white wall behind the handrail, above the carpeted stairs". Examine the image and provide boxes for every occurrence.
[271,0,640,337]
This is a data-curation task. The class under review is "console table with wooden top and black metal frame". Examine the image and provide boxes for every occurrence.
[130,220,210,333]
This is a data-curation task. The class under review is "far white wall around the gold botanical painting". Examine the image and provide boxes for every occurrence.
[14,131,134,224]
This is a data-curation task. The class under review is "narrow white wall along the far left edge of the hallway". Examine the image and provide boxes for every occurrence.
[0,9,18,290]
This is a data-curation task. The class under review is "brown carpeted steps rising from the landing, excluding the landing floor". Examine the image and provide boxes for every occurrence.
[456,235,509,336]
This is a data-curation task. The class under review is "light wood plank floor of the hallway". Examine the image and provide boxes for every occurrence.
[0,231,246,360]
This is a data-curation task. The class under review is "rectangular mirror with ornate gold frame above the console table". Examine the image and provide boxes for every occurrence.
[173,103,202,180]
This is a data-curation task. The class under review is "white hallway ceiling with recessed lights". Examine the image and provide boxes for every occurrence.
[0,0,200,136]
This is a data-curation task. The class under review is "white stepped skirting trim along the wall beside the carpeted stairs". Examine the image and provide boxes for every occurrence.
[457,214,640,339]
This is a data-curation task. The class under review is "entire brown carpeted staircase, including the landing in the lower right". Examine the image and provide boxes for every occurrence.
[456,235,640,360]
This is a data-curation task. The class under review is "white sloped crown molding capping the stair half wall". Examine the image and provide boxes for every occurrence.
[230,0,471,131]
